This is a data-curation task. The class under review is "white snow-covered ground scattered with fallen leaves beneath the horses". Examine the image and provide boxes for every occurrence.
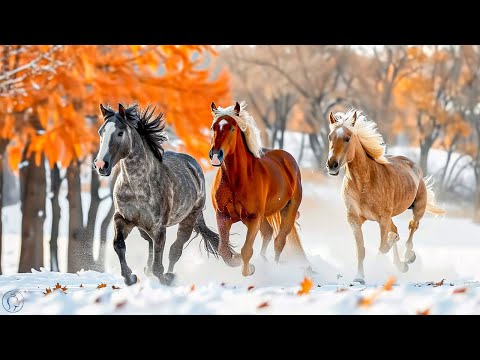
[0,139,480,314]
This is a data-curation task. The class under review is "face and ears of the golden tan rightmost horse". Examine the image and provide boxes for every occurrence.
[327,112,357,176]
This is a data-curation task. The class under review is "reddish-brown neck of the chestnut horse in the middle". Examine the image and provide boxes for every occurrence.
[222,131,257,186]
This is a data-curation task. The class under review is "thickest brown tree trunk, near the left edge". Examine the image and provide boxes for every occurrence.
[18,152,47,272]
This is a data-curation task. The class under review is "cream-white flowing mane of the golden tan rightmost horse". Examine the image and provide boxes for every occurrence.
[330,108,389,164]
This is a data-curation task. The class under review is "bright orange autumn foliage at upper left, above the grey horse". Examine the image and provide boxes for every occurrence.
[0,45,231,169]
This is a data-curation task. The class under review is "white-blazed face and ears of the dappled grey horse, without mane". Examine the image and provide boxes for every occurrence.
[93,104,132,176]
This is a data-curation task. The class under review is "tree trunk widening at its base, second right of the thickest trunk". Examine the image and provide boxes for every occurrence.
[67,160,93,272]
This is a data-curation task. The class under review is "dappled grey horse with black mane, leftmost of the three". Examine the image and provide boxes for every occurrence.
[93,104,218,285]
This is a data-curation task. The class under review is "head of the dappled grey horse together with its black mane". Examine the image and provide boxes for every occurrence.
[93,104,168,176]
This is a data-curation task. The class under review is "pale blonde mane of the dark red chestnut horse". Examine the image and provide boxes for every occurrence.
[212,101,263,158]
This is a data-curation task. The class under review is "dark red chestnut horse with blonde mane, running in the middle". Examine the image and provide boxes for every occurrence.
[209,102,306,276]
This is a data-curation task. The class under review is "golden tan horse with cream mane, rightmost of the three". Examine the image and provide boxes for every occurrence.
[327,109,445,284]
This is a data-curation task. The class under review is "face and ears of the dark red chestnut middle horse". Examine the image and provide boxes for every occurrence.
[208,102,240,166]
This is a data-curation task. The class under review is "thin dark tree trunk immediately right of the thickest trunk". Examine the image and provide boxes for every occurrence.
[50,164,62,271]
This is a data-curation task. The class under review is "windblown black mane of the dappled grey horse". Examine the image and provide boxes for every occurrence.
[101,104,168,161]
